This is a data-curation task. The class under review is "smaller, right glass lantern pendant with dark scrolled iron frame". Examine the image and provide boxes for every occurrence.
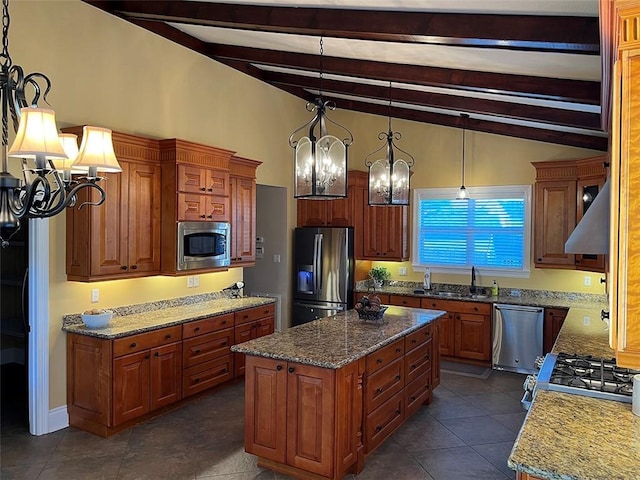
[364,82,415,205]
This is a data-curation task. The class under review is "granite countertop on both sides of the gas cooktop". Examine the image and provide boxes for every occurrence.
[507,308,640,480]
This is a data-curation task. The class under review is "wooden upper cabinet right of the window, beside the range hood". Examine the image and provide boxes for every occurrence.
[533,155,607,272]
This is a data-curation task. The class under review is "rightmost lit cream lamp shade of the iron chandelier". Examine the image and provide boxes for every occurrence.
[72,126,122,173]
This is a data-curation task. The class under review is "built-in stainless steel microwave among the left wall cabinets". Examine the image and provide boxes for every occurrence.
[176,222,231,271]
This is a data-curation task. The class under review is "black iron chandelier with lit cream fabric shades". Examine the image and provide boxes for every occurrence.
[0,0,122,247]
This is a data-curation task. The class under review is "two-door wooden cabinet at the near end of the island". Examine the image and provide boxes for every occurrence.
[245,356,362,478]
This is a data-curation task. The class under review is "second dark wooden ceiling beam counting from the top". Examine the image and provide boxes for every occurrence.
[206,44,600,105]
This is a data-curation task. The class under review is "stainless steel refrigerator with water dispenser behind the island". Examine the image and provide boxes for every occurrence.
[291,227,355,326]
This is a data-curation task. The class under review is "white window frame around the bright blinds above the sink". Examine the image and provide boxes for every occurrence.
[411,185,532,278]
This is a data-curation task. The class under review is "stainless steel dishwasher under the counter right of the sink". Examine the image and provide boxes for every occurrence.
[492,303,544,373]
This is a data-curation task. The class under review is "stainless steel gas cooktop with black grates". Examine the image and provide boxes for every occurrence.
[522,352,640,409]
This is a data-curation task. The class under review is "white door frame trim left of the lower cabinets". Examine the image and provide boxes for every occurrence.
[27,218,50,435]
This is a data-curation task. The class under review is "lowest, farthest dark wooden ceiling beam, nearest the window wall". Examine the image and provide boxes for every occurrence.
[325,97,608,152]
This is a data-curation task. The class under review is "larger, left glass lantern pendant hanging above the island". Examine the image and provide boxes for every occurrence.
[289,37,353,199]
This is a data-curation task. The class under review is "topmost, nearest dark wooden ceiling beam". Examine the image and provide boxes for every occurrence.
[85,0,600,55]
